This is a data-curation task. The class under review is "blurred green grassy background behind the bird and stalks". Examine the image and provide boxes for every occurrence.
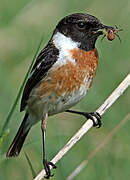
[0,0,130,180]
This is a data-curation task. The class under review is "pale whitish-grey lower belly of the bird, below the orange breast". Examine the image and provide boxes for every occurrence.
[27,81,86,124]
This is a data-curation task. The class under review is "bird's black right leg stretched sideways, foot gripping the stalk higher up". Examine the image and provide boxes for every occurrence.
[66,110,102,128]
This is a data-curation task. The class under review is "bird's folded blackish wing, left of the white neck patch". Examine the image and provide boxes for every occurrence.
[20,42,59,111]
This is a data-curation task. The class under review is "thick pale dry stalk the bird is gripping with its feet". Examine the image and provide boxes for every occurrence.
[34,73,130,180]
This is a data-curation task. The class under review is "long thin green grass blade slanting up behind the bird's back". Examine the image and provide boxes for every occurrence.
[0,37,43,137]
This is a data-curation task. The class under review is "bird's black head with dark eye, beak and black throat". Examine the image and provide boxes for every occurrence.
[54,13,116,51]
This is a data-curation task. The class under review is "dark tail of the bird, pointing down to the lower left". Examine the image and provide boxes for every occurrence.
[6,114,30,157]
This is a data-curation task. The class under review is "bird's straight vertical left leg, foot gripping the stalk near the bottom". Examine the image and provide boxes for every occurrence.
[41,114,56,179]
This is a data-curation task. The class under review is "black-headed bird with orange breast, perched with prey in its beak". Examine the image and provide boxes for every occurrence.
[6,13,121,178]
